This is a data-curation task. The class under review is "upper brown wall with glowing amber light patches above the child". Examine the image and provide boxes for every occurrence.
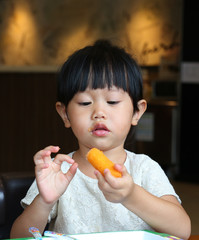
[0,0,182,66]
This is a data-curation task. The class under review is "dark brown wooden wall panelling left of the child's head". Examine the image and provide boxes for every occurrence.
[0,72,77,172]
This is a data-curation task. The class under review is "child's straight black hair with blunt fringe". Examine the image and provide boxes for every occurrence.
[57,40,143,111]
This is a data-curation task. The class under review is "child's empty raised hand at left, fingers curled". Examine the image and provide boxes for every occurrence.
[34,146,78,204]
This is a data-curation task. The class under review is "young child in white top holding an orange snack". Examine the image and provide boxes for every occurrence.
[11,40,190,239]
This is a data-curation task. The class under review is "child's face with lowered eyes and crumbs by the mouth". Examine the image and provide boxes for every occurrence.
[59,87,144,150]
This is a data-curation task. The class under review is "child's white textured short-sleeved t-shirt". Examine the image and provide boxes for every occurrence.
[21,151,181,234]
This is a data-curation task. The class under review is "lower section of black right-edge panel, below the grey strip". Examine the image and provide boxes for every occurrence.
[180,84,199,181]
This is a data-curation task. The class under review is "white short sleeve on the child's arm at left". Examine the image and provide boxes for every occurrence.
[21,180,57,222]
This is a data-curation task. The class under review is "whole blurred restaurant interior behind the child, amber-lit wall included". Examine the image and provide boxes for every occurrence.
[0,0,199,234]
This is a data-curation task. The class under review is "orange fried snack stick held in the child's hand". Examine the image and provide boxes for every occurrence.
[87,148,122,177]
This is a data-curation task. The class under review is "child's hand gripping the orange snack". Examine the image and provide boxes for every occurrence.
[95,164,134,203]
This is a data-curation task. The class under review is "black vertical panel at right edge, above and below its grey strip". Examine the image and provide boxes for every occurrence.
[179,0,199,182]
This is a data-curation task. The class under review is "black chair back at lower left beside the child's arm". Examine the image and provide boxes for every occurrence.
[0,172,34,239]
